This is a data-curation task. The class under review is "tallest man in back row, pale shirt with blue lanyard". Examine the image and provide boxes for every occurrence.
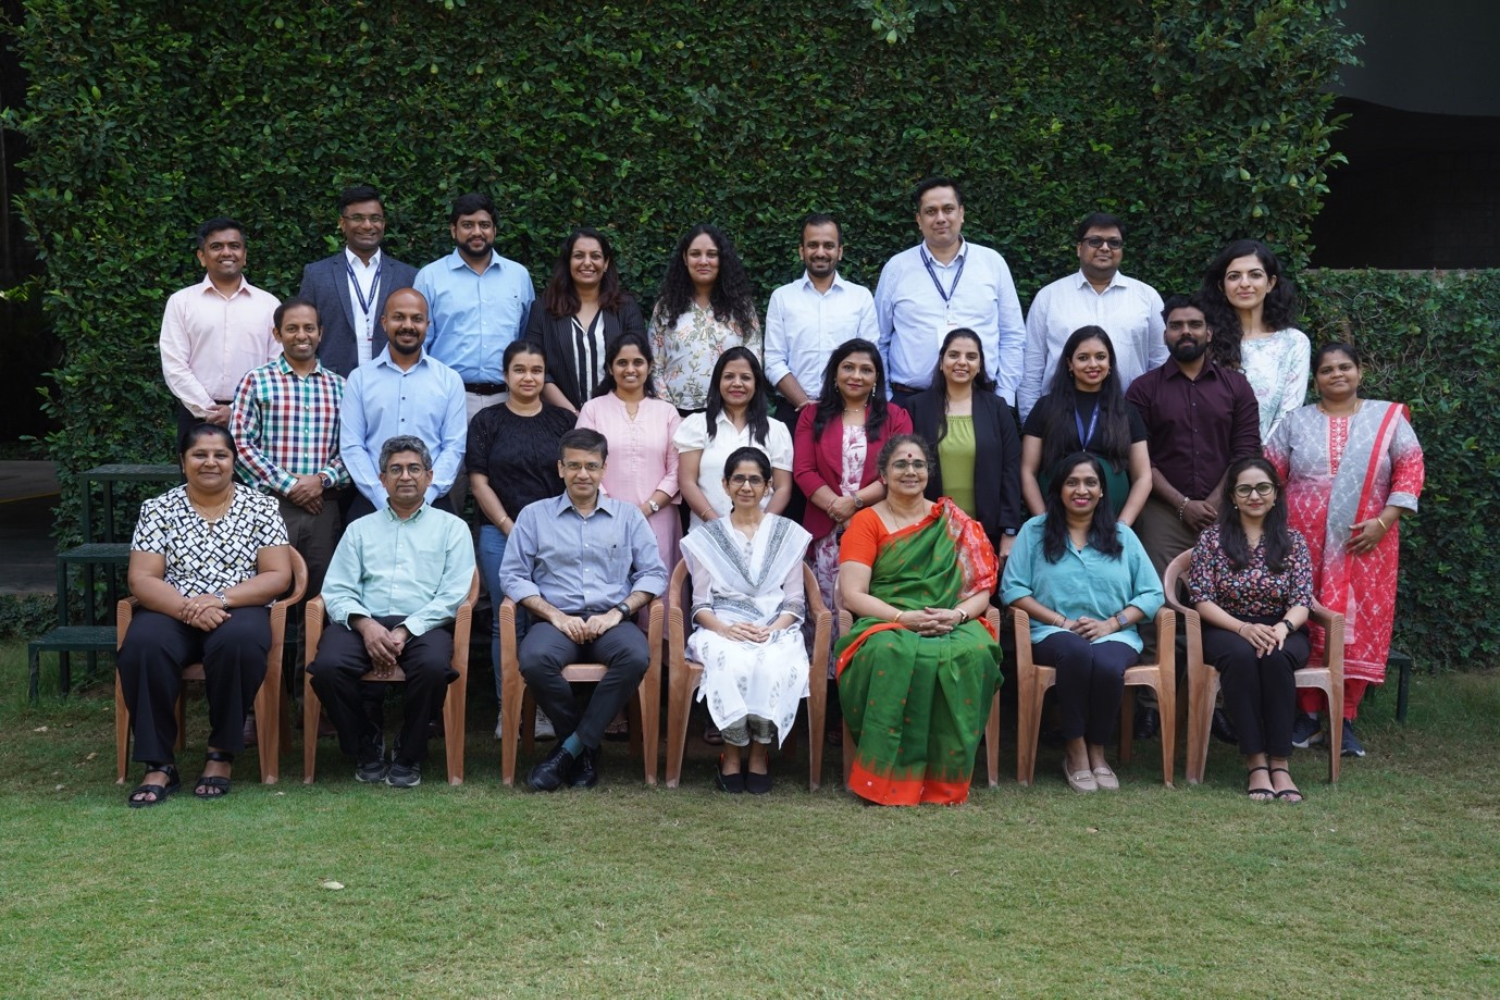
[875,177,1026,406]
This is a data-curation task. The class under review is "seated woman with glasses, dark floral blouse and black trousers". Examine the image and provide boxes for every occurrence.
[1188,459,1313,802]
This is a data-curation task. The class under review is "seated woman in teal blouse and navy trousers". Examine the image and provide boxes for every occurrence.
[1001,451,1166,792]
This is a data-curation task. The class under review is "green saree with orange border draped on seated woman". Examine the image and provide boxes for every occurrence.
[834,498,1001,805]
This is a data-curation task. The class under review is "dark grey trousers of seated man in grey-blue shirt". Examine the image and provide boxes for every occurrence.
[516,621,651,750]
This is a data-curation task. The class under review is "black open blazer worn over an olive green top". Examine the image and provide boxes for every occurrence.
[906,384,1026,546]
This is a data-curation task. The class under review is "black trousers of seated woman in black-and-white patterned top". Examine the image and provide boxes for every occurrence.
[116,607,272,763]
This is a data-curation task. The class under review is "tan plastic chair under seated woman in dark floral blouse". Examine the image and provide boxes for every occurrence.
[1163,552,1344,784]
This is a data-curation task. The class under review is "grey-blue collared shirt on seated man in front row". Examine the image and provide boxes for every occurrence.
[500,493,666,618]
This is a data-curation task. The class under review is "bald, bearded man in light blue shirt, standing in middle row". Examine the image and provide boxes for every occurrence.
[339,288,468,520]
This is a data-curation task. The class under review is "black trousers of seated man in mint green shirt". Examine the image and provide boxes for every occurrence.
[308,615,459,763]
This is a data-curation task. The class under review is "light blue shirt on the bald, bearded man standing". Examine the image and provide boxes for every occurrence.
[339,346,468,510]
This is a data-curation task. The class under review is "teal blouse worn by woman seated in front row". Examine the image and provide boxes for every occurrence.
[1001,514,1167,652]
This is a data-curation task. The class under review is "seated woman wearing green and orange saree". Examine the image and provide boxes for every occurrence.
[834,435,1001,805]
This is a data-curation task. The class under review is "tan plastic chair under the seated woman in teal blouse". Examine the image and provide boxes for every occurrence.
[1011,607,1178,789]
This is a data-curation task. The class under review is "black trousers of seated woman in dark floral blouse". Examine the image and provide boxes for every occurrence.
[1203,615,1308,757]
